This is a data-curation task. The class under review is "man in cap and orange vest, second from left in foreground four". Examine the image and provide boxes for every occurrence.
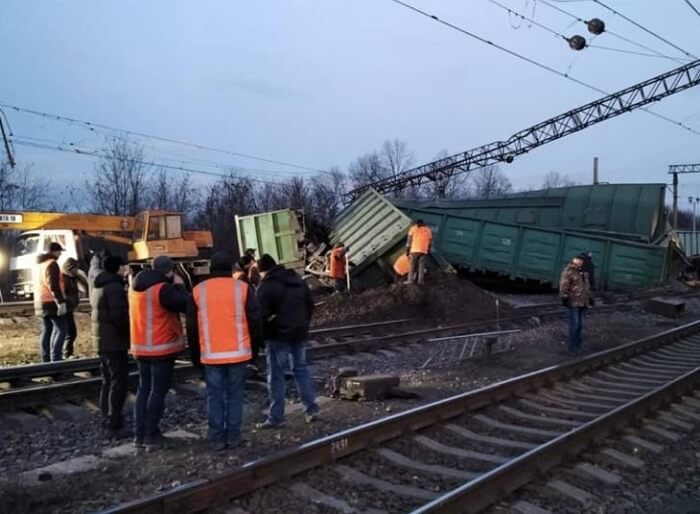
[129,255,189,448]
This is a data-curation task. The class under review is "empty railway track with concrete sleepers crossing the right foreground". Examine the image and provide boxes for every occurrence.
[101,322,700,514]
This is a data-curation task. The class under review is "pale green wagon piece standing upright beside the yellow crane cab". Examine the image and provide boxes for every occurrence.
[235,209,306,273]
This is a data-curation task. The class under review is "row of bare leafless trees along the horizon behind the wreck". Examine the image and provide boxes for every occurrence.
[0,138,588,249]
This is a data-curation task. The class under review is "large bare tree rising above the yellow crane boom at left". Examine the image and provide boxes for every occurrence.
[86,137,148,216]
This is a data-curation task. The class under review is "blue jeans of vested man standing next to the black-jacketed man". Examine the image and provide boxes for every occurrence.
[204,362,248,445]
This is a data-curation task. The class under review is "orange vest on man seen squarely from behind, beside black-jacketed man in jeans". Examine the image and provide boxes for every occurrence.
[192,277,253,364]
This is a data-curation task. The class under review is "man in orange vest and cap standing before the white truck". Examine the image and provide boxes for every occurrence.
[33,243,68,362]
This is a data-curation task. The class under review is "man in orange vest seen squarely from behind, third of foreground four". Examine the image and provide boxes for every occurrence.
[187,253,263,451]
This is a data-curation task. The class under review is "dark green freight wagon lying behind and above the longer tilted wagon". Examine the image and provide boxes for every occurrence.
[392,184,667,243]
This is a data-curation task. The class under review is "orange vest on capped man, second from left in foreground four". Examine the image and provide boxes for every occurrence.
[129,282,185,357]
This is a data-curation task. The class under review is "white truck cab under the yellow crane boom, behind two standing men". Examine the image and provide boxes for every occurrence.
[10,229,79,300]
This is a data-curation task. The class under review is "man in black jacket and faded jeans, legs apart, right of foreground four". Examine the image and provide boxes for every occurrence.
[257,254,319,428]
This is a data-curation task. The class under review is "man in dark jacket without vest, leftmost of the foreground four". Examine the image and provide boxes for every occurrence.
[90,257,129,434]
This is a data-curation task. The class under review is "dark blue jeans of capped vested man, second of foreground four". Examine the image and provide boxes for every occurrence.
[134,357,175,438]
